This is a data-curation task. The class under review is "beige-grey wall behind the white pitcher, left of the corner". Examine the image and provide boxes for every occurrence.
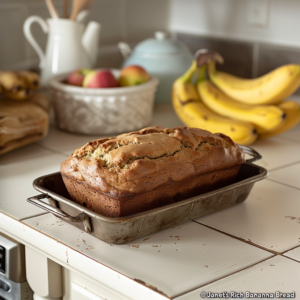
[0,0,170,69]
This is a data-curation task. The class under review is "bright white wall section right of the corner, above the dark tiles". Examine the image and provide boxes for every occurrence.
[169,0,300,47]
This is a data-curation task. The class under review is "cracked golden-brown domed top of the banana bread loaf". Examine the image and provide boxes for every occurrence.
[61,127,245,197]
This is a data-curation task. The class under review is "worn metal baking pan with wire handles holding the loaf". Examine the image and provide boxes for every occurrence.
[27,146,268,244]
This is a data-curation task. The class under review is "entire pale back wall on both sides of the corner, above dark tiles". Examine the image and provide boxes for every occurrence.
[0,0,300,69]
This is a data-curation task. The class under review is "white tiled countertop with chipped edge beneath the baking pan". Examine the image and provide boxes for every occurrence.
[0,106,300,300]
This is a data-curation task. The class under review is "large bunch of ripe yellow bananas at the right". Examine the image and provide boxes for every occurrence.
[172,51,300,145]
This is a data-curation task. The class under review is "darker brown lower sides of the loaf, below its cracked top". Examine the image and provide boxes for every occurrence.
[62,166,240,217]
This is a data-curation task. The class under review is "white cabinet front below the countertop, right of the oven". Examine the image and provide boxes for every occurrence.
[26,247,130,300]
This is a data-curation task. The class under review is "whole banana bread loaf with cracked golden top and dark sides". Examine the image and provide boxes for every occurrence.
[61,127,245,217]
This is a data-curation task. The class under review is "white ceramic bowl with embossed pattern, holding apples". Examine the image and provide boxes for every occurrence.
[49,70,158,134]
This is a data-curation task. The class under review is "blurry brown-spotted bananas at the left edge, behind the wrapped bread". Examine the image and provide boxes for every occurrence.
[0,71,40,100]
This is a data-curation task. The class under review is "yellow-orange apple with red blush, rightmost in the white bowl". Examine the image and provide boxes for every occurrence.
[119,65,150,86]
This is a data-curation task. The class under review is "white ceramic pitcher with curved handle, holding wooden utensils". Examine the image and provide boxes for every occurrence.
[23,16,101,86]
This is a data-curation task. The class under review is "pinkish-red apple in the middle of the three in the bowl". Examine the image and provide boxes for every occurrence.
[83,70,118,88]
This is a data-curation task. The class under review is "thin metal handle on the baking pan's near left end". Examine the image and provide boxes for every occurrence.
[27,194,92,233]
